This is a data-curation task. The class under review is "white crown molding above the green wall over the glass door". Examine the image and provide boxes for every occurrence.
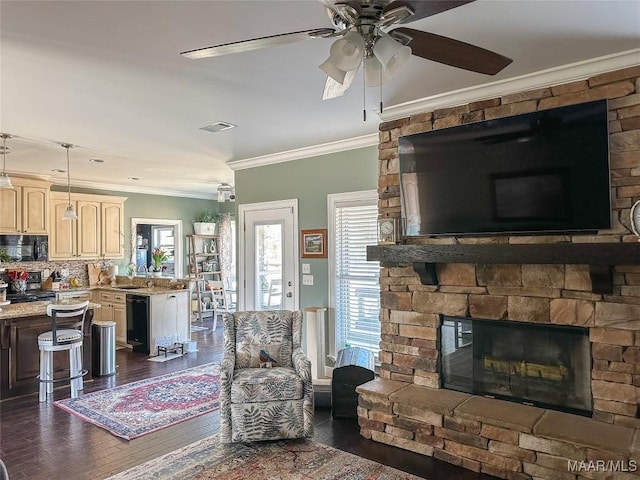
[227,133,379,171]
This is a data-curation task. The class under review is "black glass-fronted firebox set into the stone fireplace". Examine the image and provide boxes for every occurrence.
[440,315,593,416]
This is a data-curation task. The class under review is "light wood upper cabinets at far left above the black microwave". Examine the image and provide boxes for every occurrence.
[0,175,51,235]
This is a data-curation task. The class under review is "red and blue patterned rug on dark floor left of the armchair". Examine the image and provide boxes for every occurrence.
[54,363,220,440]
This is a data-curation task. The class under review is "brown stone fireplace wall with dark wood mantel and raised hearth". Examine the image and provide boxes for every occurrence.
[358,67,640,480]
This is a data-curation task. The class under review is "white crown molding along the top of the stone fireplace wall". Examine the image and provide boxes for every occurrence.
[376,48,640,122]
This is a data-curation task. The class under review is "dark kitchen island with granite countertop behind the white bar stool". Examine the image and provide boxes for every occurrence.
[0,301,100,401]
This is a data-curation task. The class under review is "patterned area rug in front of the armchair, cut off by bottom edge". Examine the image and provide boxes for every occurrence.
[107,435,420,480]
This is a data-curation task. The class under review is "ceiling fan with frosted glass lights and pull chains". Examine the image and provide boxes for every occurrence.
[181,0,512,99]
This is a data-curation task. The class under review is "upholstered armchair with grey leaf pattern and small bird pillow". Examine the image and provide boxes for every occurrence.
[220,310,313,443]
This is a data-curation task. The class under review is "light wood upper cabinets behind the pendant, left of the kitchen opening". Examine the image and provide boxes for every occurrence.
[49,192,126,260]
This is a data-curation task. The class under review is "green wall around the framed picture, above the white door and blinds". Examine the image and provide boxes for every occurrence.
[235,146,378,309]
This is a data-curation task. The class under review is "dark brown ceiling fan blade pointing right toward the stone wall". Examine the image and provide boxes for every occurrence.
[390,27,513,75]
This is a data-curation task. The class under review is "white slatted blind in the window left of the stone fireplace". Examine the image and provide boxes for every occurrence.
[334,202,380,357]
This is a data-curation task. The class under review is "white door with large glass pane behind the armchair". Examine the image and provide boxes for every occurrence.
[238,199,299,310]
